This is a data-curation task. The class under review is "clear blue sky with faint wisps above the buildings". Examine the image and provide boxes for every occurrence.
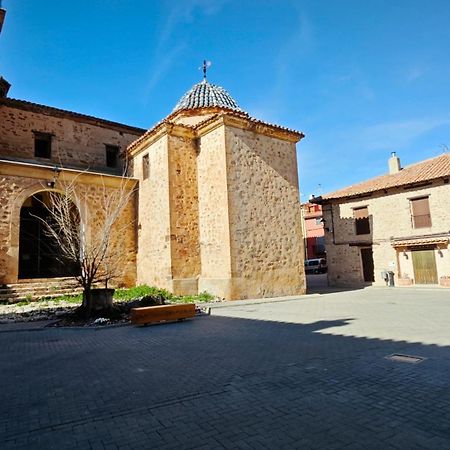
[0,0,450,200]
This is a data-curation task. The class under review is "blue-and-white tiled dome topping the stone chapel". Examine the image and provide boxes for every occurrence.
[173,79,242,112]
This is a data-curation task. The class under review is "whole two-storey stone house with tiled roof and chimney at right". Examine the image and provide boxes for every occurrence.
[313,153,450,286]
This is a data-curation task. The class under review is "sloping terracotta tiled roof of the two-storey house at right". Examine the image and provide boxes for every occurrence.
[317,153,450,200]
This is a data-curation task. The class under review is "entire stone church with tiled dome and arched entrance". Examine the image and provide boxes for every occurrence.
[0,6,305,299]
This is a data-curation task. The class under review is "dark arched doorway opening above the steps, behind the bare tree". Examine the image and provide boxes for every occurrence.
[19,191,79,279]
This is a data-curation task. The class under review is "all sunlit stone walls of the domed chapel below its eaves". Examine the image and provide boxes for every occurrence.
[129,111,305,299]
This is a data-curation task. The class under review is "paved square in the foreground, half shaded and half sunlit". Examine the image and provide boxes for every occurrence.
[0,288,450,449]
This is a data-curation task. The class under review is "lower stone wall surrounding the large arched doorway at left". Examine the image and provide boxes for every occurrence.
[0,163,136,286]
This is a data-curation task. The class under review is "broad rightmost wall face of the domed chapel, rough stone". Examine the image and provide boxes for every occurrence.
[226,127,305,298]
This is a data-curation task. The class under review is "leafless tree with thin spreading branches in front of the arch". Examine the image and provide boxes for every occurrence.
[39,174,135,317]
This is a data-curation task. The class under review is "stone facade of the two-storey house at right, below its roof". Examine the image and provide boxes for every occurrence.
[323,180,450,286]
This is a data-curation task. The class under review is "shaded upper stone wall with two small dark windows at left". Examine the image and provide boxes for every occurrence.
[0,103,141,173]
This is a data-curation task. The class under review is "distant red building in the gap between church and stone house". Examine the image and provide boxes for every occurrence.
[302,202,326,259]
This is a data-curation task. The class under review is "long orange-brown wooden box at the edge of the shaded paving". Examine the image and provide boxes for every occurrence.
[131,303,195,325]
